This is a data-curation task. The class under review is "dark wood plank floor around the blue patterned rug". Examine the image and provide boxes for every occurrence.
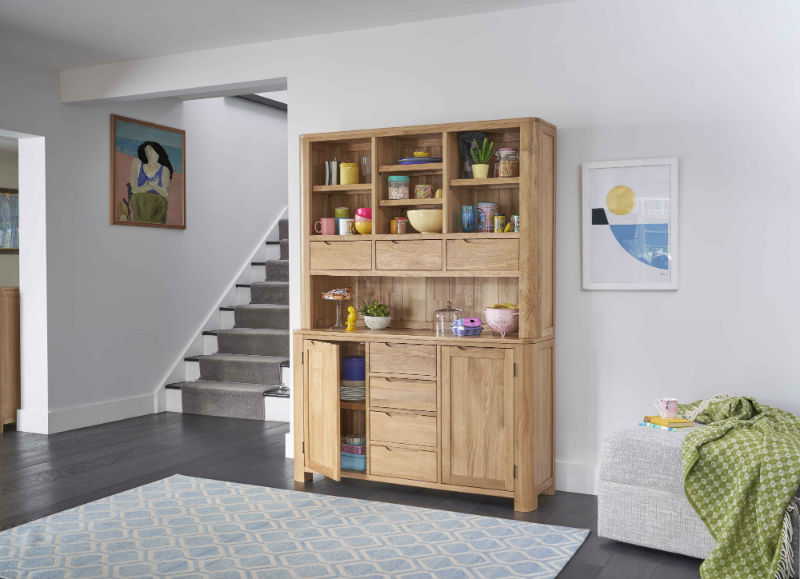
[0,413,700,579]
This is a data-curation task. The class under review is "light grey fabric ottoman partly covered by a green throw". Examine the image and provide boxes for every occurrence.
[597,426,800,575]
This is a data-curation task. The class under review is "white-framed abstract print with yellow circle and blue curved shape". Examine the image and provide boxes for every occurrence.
[581,157,680,290]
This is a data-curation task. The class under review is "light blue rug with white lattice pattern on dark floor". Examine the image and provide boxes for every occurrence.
[0,475,589,579]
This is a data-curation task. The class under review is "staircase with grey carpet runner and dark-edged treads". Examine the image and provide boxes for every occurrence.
[172,219,290,420]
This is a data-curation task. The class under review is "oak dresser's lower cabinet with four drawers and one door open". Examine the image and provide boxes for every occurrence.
[293,331,554,511]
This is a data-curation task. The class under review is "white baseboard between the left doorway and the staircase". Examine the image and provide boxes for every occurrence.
[17,394,158,434]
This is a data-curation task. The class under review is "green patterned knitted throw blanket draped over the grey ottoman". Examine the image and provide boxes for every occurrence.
[678,394,800,579]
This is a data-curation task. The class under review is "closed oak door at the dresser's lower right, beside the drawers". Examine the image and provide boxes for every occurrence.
[442,346,514,490]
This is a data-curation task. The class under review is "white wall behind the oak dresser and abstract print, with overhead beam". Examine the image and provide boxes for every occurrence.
[56,0,800,491]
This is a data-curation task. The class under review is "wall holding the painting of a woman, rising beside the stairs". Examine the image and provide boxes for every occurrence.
[0,52,287,431]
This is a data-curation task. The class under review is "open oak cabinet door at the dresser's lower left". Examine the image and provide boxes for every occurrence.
[303,340,341,481]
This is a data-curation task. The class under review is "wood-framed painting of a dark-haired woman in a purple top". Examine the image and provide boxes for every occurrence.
[111,115,186,229]
